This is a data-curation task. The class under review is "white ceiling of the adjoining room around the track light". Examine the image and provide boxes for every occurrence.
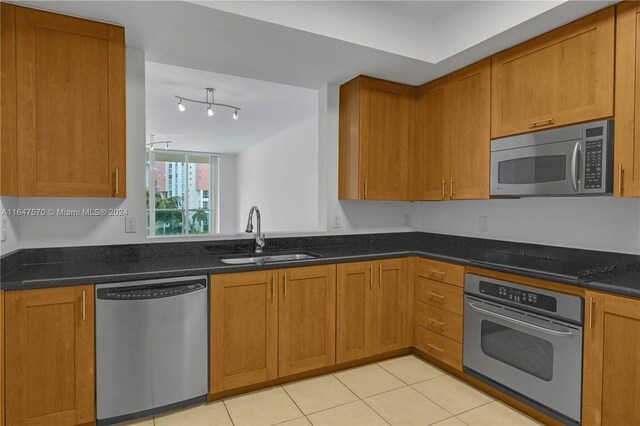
[145,62,318,153]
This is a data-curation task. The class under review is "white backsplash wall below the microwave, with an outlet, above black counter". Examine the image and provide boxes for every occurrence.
[415,197,640,254]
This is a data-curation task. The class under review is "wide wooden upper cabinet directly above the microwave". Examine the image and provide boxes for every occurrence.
[491,7,615,138]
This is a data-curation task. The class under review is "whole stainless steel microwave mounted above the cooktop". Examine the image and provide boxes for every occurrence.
[491,120,613,197]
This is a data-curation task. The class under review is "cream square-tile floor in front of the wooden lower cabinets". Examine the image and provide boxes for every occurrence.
[120,355,539,426]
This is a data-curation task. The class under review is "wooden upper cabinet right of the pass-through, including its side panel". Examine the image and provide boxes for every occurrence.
[338,76,415,200]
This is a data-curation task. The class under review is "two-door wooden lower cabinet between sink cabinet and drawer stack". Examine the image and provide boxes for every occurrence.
[336,259,409,363]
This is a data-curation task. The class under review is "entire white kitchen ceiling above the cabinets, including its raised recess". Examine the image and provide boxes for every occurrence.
[17,0,615,88]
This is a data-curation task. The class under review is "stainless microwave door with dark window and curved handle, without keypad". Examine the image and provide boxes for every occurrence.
[491,139,582,196]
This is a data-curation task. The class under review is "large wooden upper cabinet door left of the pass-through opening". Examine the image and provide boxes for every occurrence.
[16,7,126,197]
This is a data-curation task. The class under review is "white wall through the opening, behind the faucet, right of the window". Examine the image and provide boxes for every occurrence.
[236,118,318,232]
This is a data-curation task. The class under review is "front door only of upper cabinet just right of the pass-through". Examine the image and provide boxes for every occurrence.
[360,77,415,200]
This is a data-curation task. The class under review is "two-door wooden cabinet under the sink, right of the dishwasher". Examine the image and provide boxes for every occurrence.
[210,265,336,393]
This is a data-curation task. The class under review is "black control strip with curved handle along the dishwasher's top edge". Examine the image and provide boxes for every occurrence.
[96,281,207,301]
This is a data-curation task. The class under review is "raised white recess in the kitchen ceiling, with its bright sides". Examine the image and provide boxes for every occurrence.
[192,0,565,63]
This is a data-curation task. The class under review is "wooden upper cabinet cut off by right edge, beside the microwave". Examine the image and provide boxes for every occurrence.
[613,1,640,197]
